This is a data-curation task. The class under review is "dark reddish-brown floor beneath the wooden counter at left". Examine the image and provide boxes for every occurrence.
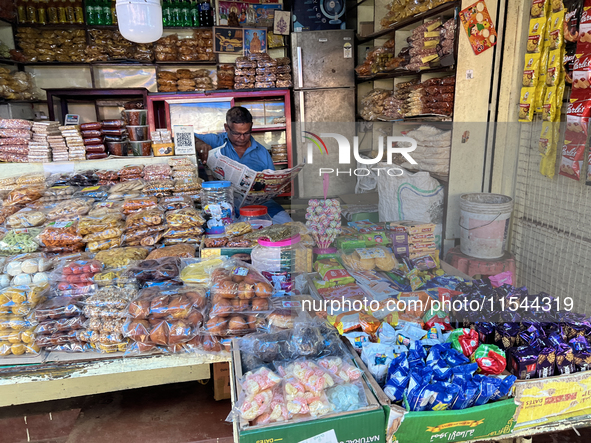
[0,380,232,443]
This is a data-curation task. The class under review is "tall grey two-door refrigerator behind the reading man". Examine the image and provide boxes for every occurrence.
[291,30,356,198]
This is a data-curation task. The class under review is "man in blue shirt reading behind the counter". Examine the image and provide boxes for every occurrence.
[195,106,291,224]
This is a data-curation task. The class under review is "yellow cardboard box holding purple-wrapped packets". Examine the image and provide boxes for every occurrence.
[515,371,591,431]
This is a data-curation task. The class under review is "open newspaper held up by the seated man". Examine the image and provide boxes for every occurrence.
[207,147,304,208]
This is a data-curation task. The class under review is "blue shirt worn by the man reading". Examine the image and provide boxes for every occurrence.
[195,132,284,217]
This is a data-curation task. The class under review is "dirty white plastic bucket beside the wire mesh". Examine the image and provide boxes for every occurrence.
[460,194,513,259]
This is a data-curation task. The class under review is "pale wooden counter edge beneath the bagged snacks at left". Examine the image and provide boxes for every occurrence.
[0,353,230,407]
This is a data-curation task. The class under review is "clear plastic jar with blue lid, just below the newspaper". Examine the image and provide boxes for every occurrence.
[201,181,234,235]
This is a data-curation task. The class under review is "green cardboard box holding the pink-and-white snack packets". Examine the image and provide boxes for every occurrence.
[231,342,385,443]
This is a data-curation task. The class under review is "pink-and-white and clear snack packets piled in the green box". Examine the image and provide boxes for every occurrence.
[228,318,368,426]
